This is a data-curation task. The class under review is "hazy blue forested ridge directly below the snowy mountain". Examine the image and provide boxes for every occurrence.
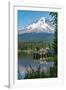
[18,33,54,42]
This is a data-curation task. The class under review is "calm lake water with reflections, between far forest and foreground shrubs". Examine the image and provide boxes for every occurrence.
[18,53,54,79]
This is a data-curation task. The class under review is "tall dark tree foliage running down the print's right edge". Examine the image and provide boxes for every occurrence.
[50,12,58,77]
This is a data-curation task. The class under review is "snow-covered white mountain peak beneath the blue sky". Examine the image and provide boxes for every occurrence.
[18,17,54,34]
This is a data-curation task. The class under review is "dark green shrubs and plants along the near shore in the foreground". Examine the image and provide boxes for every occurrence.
[18,61,57,80]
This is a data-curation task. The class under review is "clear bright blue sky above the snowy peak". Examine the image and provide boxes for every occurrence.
[17,10,51,30]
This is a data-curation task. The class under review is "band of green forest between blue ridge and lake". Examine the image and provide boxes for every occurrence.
[18,41,48,51]
